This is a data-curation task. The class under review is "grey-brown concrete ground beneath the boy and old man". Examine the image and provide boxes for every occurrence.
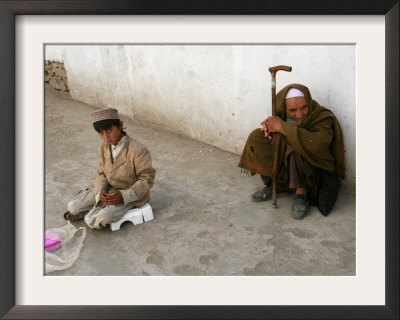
[45,88,356,276]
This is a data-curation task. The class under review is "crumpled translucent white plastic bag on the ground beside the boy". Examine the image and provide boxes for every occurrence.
[45,221,86,273]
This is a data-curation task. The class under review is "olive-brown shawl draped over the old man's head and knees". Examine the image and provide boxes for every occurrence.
[238,84,346,178]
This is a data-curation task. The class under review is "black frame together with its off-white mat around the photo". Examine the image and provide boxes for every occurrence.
[0,0,399,319]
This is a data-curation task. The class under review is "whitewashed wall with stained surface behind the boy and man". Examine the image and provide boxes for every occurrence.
[45,45,356,191]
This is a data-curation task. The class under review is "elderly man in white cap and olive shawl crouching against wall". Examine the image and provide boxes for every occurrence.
[238,84,345,219]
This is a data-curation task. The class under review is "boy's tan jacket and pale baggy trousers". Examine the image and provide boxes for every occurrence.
[68,135,156,229]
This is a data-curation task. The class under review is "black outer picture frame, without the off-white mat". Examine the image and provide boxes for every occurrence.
[0,0,400,319]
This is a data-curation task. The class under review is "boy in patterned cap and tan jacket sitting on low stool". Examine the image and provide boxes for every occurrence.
[64,108,156,229]
